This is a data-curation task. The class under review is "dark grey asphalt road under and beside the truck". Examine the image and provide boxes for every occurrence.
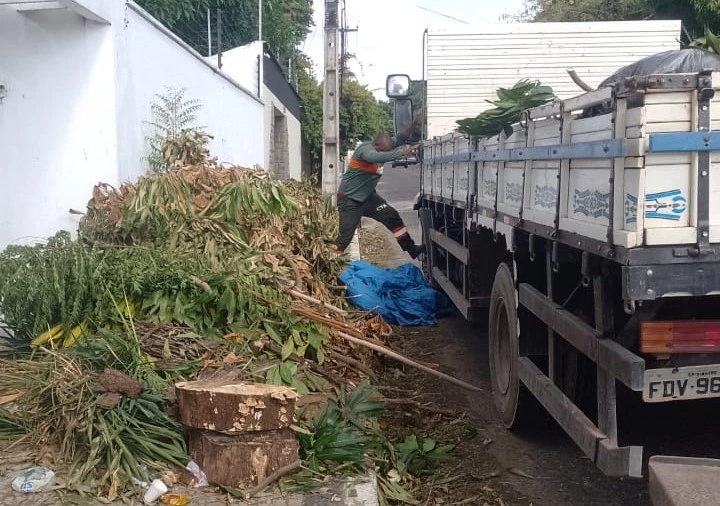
[374,165,720,506]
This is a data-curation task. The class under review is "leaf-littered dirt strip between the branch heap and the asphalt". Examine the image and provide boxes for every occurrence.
[359,225,537,506]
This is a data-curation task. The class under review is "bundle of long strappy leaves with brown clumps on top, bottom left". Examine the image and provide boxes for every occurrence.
[0,329,190,501]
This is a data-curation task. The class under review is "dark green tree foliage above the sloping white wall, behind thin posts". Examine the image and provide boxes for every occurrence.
[138,0,313,65]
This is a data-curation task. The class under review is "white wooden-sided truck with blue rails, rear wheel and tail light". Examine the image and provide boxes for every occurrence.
[420,72,720,476]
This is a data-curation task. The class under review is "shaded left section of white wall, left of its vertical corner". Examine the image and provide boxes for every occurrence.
[0,5,118,249]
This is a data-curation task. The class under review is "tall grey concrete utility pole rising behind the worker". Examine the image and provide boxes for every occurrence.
[322,0,340,203]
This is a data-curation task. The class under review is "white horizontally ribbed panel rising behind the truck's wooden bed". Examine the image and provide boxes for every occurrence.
[426,21,680,137]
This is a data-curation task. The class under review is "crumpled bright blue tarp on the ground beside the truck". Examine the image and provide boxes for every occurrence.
[340,260,448,326]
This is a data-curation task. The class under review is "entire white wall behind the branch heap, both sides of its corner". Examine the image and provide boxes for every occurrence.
[0,0,265,250]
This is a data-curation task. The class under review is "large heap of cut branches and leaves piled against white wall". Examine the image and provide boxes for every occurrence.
[0,162,416,498]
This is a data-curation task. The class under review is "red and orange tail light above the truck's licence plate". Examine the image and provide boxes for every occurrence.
[640,320,720,354]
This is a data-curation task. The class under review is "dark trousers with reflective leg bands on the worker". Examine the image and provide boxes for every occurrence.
[335,192,415,252]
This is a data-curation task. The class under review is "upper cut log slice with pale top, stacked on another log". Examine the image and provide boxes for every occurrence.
[175,380,298,434]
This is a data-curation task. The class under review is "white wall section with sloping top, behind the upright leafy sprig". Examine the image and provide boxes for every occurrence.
[116,4,264,179]
